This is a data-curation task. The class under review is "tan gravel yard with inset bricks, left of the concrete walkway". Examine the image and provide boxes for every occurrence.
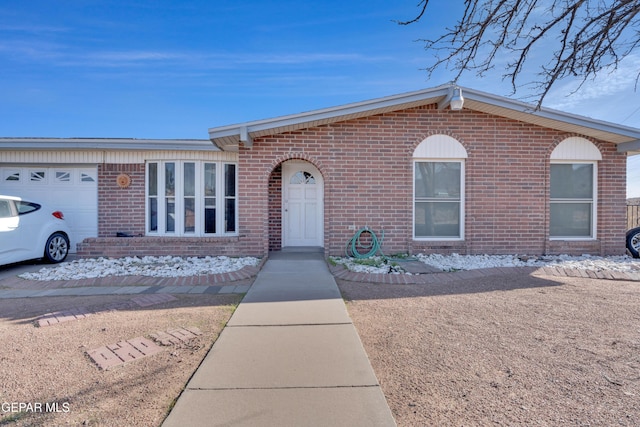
[0,295,241,426]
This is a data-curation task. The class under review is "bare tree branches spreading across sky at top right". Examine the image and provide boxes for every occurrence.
[398,0,640,107]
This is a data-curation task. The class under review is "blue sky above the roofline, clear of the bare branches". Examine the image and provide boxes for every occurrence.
[0,0,640,197]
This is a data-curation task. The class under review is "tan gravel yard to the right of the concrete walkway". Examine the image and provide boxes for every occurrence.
[340,275,640,426]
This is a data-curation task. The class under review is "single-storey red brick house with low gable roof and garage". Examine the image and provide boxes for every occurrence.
[0,85,640,256]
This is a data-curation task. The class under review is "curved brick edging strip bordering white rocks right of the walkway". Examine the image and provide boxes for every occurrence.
[328,263,640,285]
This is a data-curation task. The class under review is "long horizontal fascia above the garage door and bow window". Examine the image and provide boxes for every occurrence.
[0,138,219,151]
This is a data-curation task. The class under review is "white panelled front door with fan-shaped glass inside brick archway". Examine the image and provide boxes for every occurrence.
[282,160,324,246]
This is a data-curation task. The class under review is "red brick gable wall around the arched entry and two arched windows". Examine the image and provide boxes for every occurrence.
[239,106,626,255]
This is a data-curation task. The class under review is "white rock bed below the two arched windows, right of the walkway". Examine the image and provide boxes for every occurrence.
[332,254,640,274]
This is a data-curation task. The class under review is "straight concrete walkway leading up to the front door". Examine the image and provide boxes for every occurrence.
[163,252,396,427]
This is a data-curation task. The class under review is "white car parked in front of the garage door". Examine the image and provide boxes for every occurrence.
[0,195,69,265]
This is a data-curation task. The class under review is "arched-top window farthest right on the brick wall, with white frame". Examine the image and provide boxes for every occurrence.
[549,137,602,240]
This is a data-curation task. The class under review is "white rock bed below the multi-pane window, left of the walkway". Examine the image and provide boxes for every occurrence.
[20,256,260,280]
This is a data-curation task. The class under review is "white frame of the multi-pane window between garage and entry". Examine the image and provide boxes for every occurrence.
[144,160,238,237]
